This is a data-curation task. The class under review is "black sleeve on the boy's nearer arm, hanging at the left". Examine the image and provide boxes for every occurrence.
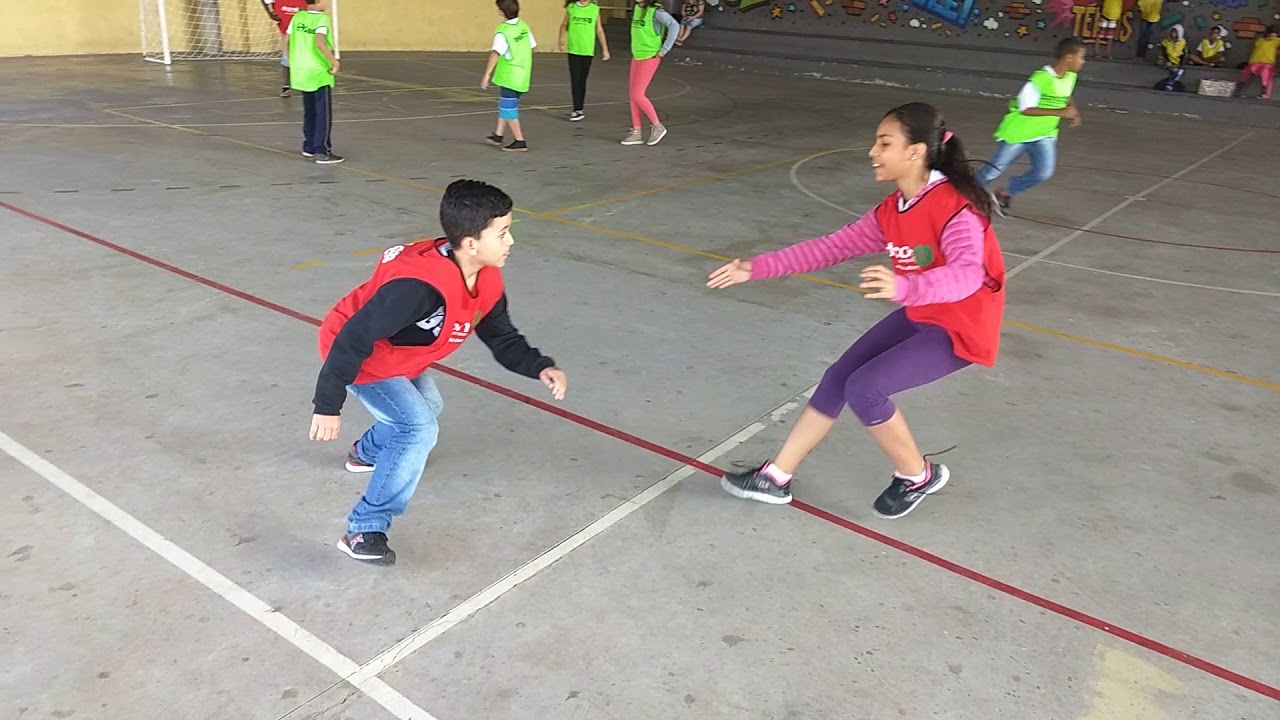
[312,278,445,415]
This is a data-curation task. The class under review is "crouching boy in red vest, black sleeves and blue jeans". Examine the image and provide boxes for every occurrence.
[311,179,567,565]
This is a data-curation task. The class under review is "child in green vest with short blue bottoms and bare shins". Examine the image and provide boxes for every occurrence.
[480,0,538,152]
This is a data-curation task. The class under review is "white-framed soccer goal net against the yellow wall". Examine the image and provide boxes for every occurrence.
[138,0,338,65]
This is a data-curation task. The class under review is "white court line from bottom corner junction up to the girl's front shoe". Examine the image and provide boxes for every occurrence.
[348,417,768,687]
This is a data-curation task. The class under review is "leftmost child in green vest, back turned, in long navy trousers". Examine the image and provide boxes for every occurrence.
[285,0,346,165]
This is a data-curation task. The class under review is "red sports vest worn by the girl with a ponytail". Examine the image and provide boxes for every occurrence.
[876,181,1005,368]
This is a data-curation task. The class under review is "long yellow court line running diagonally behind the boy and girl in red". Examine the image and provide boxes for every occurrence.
[94,110,1280,391]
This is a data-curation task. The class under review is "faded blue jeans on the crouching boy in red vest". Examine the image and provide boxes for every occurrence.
[347,373,444,533]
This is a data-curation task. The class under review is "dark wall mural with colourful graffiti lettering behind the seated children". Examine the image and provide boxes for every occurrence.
[708,0,1280,60]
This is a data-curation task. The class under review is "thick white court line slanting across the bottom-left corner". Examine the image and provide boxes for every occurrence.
[0,432,435,720]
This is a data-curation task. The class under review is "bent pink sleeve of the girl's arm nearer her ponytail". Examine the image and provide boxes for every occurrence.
[893,208,987,305]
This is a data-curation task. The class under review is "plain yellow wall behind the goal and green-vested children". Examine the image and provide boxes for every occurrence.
[0,0,586,56]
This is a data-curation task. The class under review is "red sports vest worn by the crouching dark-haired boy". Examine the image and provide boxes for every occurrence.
[320,240,503,383]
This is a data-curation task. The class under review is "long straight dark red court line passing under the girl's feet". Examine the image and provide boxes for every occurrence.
[0,201,1280,701]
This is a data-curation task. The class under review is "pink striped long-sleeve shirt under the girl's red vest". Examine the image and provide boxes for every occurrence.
[751,183,986,305]
